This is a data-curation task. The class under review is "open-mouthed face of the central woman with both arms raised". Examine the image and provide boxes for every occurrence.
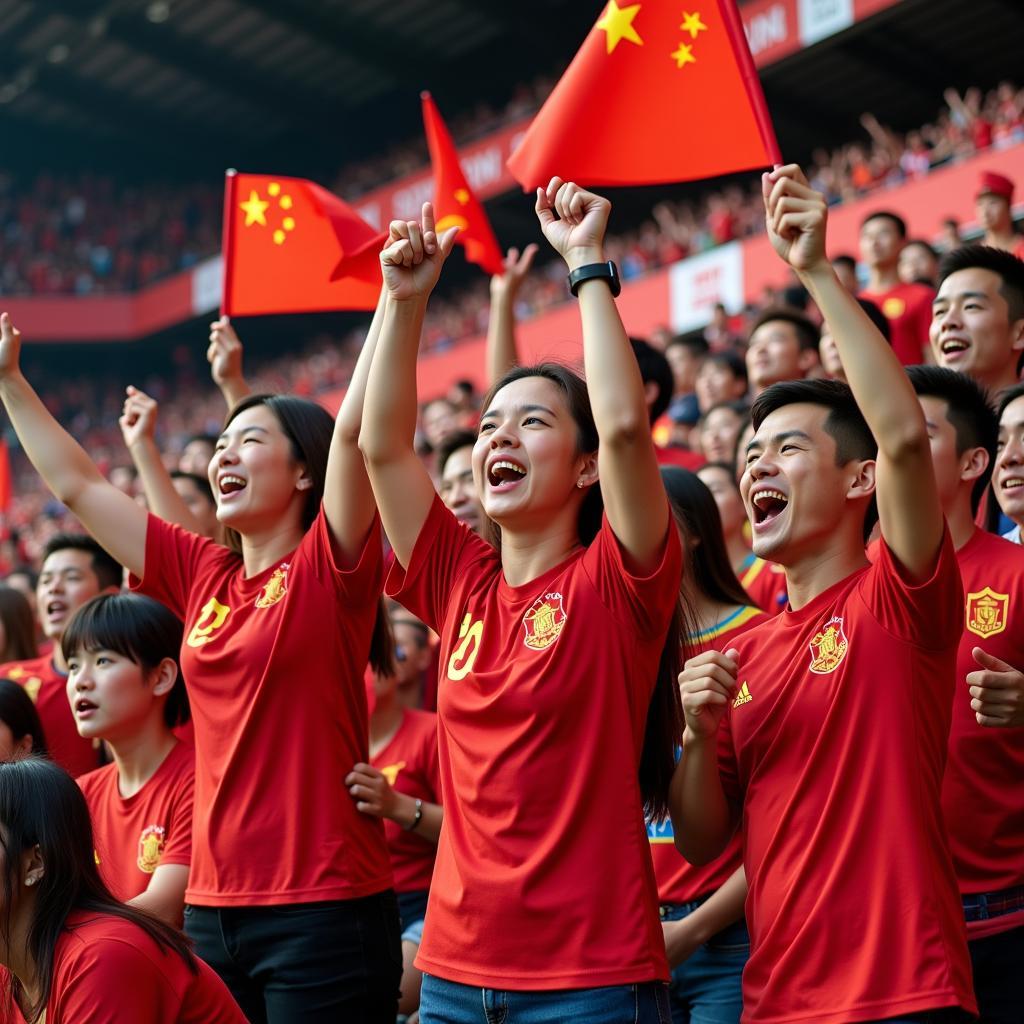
[473,377,596,529]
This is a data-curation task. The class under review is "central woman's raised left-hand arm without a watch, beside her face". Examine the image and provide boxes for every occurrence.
[359,203,456,568]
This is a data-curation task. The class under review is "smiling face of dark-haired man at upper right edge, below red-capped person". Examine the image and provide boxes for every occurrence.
[929,267,1024,388]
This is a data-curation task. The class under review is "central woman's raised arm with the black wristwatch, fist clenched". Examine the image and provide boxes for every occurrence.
[537,178,669,573]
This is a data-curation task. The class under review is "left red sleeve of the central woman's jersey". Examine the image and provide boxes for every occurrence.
[384,495,498,633]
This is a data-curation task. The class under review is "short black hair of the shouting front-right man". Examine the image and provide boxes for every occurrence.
[751,380,879,542]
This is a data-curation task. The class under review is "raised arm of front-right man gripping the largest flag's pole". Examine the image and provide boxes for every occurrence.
[763,164,944,581]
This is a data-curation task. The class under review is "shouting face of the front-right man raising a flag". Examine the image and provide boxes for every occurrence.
[739,402,873,565]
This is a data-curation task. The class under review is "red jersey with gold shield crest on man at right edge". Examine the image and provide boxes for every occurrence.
[942,529,1024,939]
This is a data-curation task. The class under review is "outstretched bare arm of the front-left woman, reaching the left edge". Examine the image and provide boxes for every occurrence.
[0,313,146,577]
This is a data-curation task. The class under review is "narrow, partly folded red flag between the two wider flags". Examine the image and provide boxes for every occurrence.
[420,92,505,273]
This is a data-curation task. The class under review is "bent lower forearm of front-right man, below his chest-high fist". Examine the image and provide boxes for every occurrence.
[669,733,734,864]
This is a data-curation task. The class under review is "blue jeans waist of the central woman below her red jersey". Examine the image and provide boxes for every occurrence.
[420,974,672,1024]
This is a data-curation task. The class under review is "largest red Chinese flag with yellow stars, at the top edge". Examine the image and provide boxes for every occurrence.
[508,0,781,189]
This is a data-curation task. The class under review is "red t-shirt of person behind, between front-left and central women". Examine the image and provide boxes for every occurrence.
[370,711,441,893]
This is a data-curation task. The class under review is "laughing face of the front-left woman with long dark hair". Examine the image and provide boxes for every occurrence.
[209,406,311,534]
